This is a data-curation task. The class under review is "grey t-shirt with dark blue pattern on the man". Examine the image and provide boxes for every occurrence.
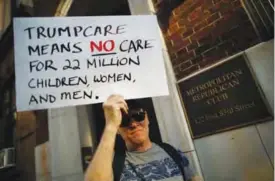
[120,143,194,181]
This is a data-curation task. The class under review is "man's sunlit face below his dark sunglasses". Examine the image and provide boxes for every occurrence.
[119,112,149,147]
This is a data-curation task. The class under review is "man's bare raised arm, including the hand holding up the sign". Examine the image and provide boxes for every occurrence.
[85,95,128,181]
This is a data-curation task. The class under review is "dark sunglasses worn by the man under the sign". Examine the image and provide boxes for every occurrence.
[120,108,146,127]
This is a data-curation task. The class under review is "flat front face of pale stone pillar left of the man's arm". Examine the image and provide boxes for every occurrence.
[48,107,84,181]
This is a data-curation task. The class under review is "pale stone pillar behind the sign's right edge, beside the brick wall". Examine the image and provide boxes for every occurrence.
[128,0,205,177]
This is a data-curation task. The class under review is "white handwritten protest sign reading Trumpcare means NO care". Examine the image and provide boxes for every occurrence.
[14,16,168,111]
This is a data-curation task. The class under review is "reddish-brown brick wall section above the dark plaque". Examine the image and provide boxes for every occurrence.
[153,0,259,80]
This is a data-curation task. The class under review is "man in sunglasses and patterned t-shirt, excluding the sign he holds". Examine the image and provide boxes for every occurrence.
[85,95,200,181]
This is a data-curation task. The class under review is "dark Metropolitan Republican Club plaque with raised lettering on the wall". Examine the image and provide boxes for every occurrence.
[178,54,273,138]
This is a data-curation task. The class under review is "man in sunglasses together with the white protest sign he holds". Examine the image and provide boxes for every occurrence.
[13,15,201,181]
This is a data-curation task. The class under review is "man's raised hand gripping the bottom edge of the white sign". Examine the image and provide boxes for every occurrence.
[103,95,128,129]
